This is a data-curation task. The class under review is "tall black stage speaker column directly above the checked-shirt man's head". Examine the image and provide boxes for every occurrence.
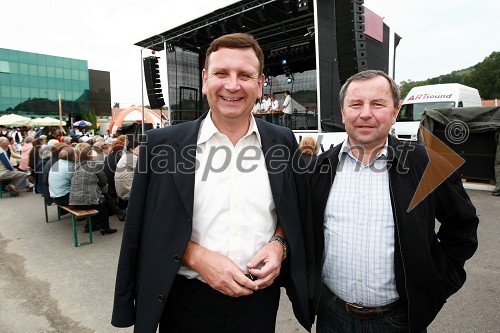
[335,0,368,84]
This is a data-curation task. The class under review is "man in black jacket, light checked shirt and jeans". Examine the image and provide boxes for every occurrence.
[309,70,479,333]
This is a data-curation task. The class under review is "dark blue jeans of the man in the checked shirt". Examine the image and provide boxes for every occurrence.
[316,285,427,333]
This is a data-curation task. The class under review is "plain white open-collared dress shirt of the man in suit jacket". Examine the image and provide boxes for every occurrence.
[179,112,277,281]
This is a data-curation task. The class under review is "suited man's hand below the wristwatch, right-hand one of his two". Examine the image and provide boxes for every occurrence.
[247,242,283,289]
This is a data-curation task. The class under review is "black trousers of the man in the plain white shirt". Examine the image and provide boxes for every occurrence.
[159,275,280,333]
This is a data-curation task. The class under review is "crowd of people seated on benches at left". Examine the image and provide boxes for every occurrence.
[0,124,139,235]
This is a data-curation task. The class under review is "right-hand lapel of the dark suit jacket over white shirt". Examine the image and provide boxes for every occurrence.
[257,121,290,207]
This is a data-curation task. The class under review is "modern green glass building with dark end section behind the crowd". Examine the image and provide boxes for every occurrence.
[0,48,111,117]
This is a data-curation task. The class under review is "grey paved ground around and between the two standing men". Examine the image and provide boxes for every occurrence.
[0,185,500,333]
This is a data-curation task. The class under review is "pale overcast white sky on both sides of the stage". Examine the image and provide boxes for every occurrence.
[0,0,500,107]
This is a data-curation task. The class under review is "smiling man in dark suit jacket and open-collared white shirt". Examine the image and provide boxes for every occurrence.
[112,34,311,332]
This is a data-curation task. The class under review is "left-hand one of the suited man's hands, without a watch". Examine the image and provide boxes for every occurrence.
[182,241,259,297]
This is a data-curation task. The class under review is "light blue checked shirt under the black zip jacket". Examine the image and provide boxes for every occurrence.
[323,140,399,307]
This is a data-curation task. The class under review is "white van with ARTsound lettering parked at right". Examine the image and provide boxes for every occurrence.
[391,83,482,141]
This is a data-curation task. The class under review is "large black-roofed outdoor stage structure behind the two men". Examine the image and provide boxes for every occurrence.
[135,0,400,132]
